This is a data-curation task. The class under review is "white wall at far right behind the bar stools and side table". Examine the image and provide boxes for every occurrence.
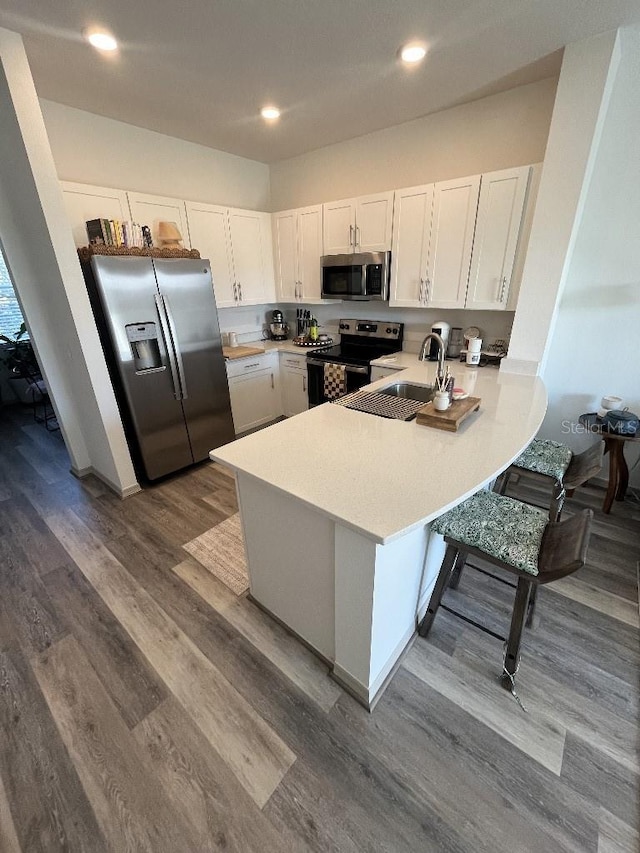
[542,29,640,486]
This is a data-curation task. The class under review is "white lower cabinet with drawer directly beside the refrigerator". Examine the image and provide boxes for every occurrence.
[227,353,282,435]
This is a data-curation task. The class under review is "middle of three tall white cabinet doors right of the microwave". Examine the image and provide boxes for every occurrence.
[426,175,480,308]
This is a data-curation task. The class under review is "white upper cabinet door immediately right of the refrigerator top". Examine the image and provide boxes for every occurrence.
[187,202,237,308]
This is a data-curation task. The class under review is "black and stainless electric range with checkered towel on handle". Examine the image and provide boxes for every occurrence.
[307,320,404,406]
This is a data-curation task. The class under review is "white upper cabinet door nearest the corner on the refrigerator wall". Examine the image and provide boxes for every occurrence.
[229,208,269,305]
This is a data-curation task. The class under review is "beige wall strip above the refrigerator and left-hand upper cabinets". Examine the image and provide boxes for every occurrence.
[41,100,270,210]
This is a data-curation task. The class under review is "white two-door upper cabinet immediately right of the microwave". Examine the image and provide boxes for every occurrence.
[389,175,480,308]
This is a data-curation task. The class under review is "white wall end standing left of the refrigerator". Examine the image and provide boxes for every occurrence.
[0,29,137,491]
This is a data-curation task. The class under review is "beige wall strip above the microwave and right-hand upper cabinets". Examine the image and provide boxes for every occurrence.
[271,78,557,210]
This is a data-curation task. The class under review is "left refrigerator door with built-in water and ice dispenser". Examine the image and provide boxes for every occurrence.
[91,256,193,480]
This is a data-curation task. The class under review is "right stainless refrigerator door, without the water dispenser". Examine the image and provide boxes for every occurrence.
[153,258,235,462]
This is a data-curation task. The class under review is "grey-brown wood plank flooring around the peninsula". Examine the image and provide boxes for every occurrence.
[0,408,640,853]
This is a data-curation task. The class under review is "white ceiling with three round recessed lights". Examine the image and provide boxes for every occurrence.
[0,0,640,163]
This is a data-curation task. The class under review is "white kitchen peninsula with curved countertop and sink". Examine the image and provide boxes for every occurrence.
[210,360,547,707]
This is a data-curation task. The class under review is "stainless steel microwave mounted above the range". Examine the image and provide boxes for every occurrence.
[321,252,391,301]
